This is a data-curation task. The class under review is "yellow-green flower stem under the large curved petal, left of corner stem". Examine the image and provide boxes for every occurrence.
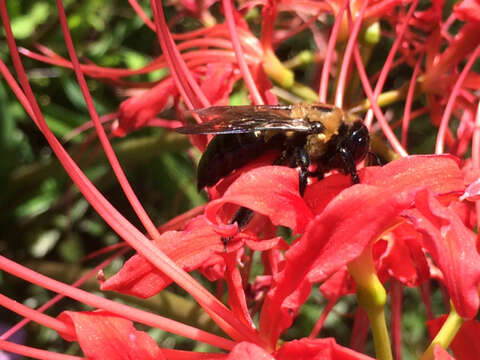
[348,247,393,360]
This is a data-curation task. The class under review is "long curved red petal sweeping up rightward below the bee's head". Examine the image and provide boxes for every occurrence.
[260,157,463,344]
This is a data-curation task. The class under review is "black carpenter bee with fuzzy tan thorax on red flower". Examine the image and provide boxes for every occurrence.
[176,103,370,235]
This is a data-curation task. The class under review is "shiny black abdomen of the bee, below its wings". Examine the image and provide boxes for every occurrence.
[197,133,271,190]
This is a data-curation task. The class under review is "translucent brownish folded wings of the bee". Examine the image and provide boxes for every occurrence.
[175,105,312,134]
